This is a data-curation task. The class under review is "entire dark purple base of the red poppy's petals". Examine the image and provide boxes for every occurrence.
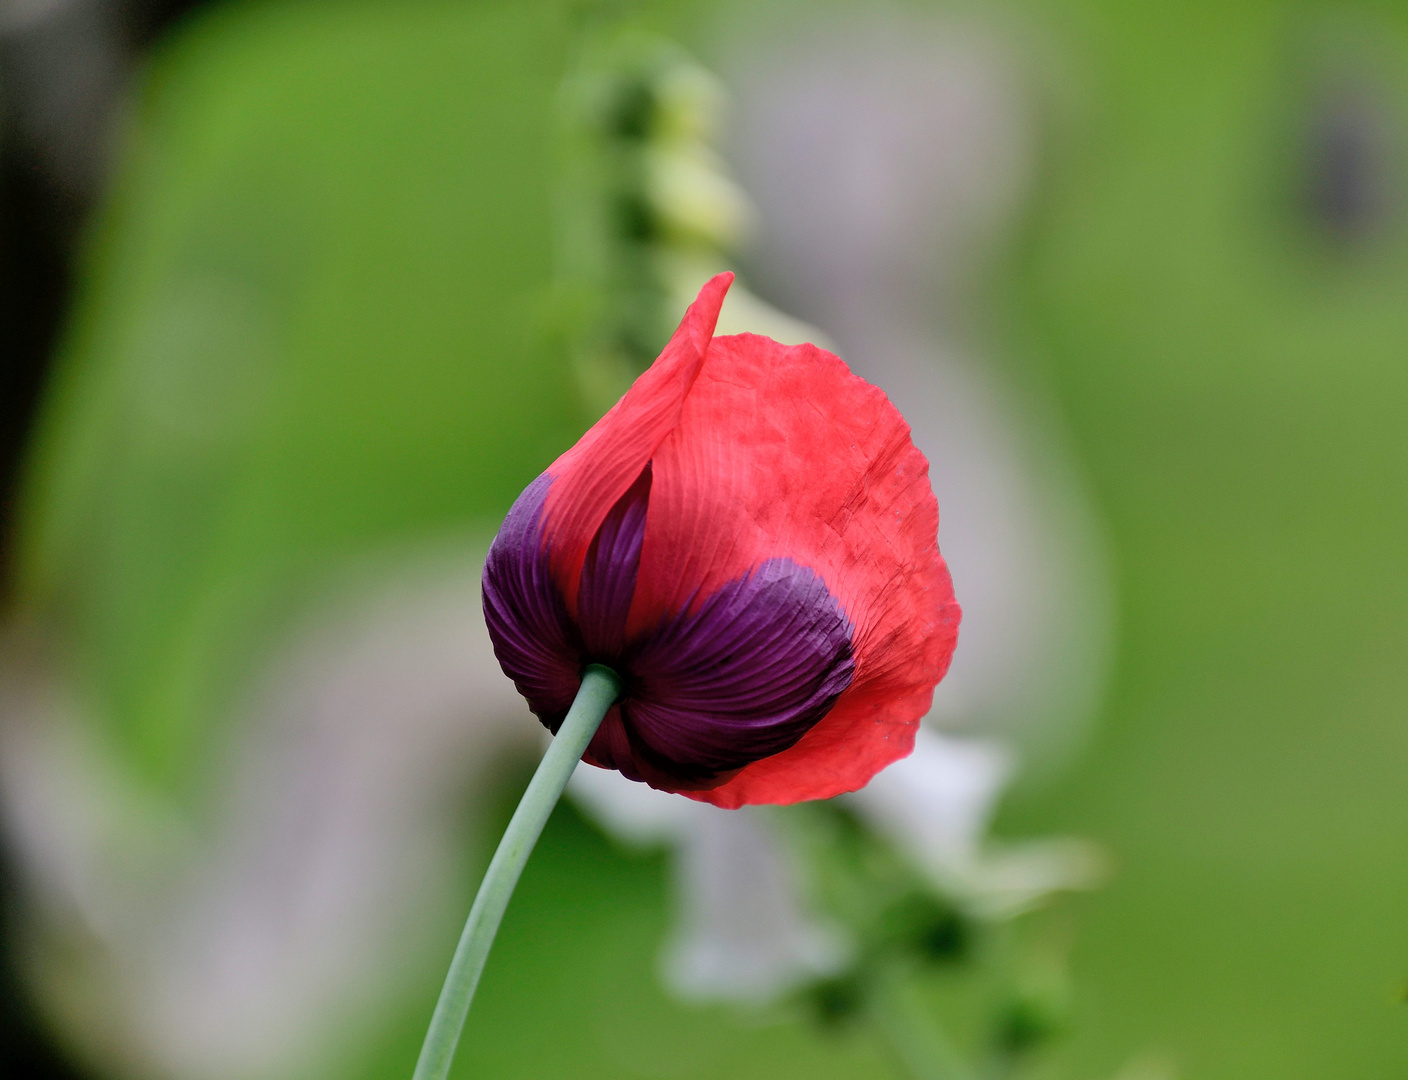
[484,467,855,790]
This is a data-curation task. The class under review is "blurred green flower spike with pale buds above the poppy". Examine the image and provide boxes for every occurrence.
[556,25,811,414]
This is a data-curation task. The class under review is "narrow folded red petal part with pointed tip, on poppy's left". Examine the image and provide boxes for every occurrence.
[543,273,734,615]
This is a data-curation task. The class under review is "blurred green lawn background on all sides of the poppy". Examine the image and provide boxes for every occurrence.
[11,0,1408,1080]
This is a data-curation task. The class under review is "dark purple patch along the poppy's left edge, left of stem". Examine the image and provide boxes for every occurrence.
[483,473,583,732]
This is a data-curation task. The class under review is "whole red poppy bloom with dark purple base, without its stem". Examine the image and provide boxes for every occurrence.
[483,273,959,807]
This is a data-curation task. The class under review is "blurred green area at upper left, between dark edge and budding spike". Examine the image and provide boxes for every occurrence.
[20,3,589,798]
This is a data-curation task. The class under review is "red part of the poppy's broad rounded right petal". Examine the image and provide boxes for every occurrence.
[636,334,959,807]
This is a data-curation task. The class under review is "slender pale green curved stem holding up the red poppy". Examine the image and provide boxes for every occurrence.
[413,663,621,1080]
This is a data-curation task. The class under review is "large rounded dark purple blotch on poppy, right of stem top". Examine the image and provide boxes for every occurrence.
[618,559,855,786]
